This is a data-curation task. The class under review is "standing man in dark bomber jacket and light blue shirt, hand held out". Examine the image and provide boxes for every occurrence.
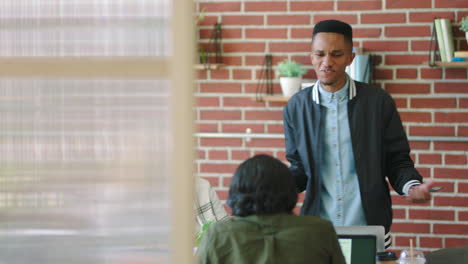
[283,20,432,246]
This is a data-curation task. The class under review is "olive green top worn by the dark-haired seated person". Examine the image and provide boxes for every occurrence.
[197,214,345,264]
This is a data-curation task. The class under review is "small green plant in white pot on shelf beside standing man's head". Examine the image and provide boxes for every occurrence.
[276,60,307,96]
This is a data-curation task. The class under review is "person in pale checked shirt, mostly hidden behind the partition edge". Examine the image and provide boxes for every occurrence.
[195,177,228,229]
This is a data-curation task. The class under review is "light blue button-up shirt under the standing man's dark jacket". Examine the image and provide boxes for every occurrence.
[315,79,367,226]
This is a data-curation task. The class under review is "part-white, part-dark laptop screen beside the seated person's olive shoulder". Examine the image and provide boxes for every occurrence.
[338,235,376,264]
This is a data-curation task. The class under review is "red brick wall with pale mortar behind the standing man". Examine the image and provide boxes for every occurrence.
[195,0,468,251]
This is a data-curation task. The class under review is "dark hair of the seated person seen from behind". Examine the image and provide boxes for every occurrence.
[227,155,297,216]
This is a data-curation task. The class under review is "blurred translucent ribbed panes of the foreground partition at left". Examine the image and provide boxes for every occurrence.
[0,0,185,264]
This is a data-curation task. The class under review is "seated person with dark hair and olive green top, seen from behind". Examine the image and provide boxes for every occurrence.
[197,155,345,264]
